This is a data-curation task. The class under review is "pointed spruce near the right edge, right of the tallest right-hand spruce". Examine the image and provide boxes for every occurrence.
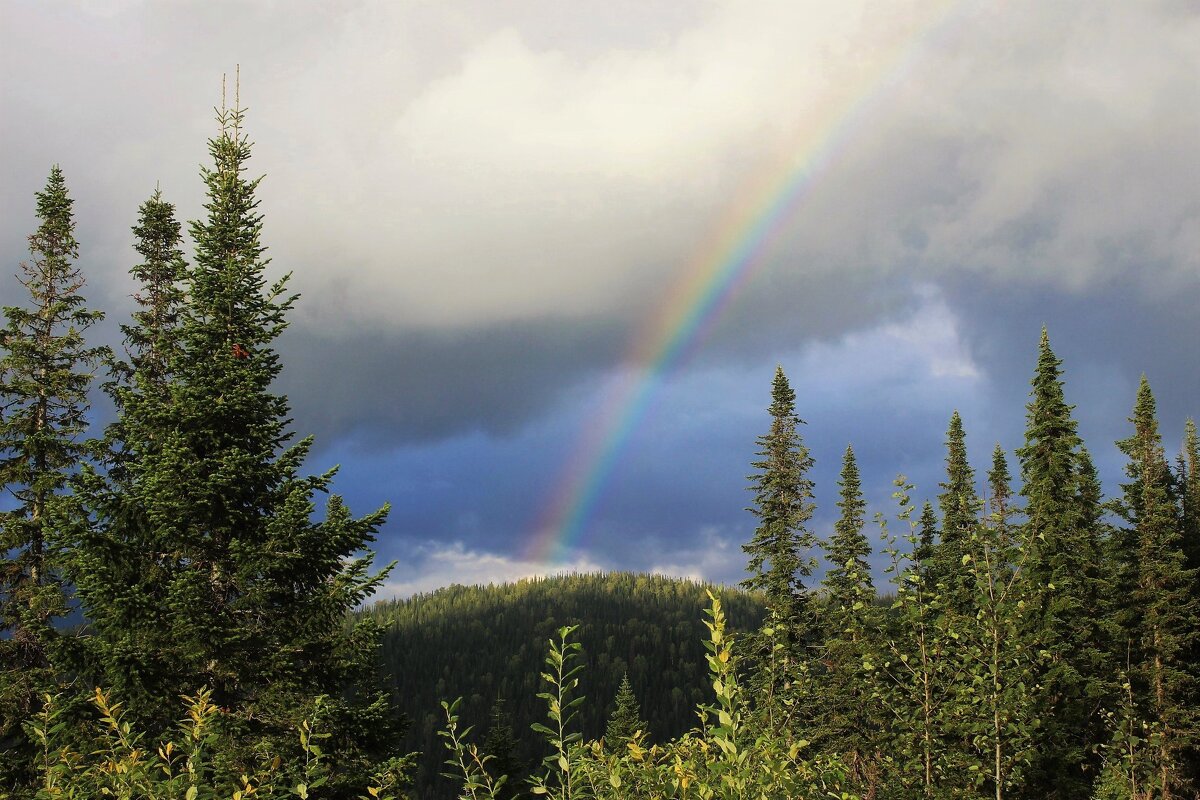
[1117,375,1200,800]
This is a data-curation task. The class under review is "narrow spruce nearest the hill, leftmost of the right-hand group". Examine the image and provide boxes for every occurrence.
[742,367,816,726]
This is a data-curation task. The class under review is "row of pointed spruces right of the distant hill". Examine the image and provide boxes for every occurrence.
[729,345,1200,800]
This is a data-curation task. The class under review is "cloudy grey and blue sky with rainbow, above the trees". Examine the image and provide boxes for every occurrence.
[0,0,1200,597]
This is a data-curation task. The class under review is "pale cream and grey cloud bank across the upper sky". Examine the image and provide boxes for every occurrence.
[14,0,1200,330]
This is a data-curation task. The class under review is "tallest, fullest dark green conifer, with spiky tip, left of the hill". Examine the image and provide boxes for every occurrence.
[80,89,397,788]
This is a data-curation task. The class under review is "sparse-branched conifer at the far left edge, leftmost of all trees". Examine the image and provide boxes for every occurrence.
[0,166,103,786]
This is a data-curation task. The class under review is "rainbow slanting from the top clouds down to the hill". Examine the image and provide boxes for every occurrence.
[524,0,971,565]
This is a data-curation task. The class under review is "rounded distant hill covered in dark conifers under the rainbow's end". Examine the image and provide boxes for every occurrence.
[360,572,762,798]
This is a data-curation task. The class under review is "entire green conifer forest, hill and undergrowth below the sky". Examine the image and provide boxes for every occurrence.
[0,95,1200,800]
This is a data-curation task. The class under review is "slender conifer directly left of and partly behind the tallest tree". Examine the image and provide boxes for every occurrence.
[72,190,187,722]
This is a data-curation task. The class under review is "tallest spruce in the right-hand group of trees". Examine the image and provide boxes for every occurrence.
[1018,329,1114,798]
